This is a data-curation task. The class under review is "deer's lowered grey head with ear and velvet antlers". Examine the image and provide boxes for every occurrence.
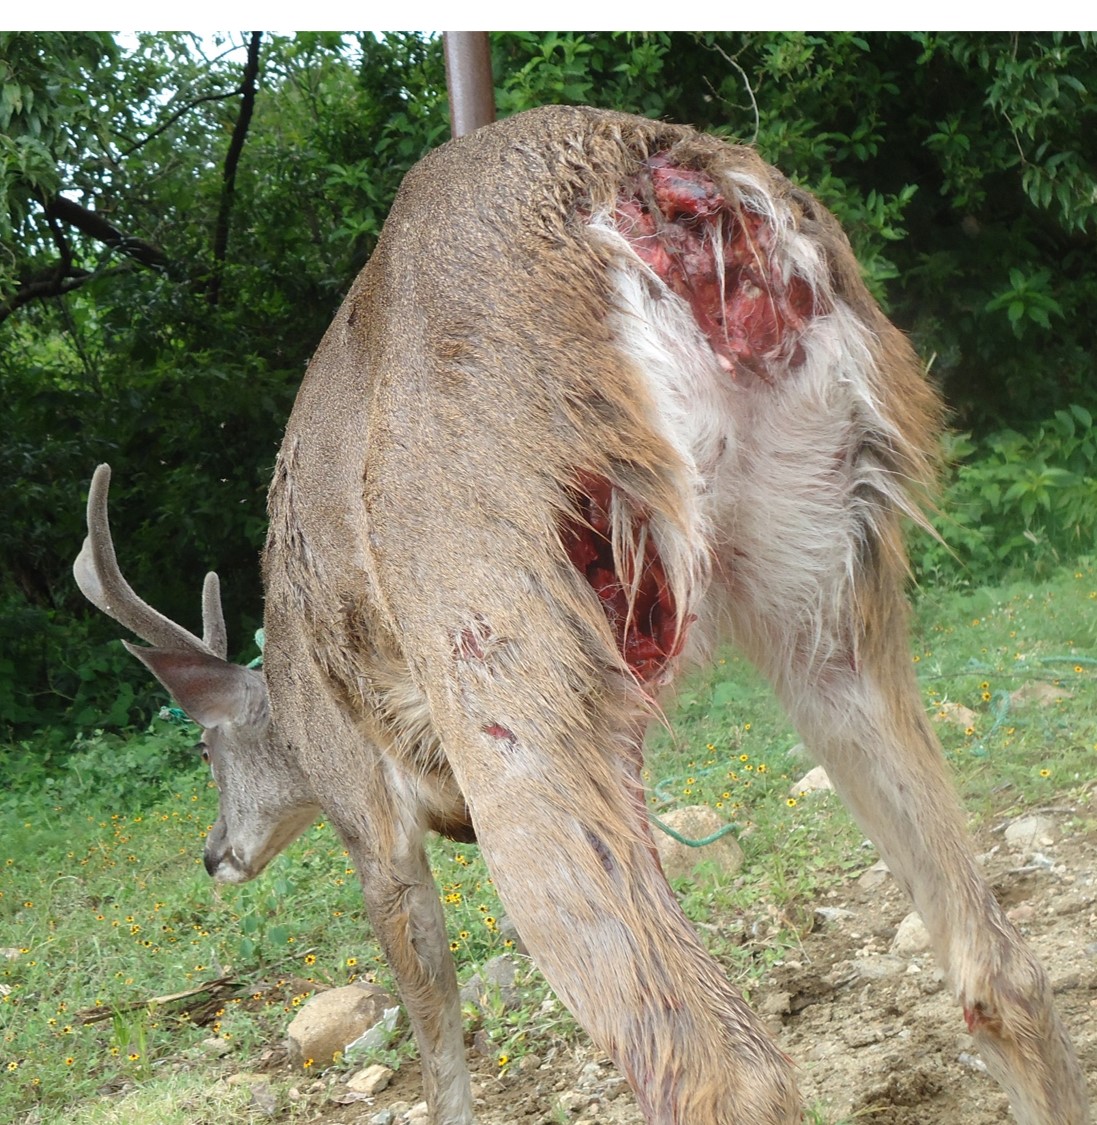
[72,465,318,883]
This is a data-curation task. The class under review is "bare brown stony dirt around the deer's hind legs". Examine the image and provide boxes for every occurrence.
[276,790,1097,1125]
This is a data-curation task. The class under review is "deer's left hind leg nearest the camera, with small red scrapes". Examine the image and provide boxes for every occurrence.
[428,616,800,1125]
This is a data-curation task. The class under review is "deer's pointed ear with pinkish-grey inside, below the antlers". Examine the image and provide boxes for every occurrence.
[123,641,257,728]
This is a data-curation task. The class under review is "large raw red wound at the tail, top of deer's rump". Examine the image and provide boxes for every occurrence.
[614,153,815,379]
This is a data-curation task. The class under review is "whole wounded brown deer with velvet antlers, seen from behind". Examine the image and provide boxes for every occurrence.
[75,108,1089,1125]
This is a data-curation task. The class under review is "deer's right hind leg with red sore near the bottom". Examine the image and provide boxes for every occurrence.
[732,461,1090,1125]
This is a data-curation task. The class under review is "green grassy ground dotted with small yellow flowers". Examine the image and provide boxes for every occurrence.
[0,563,1097,1125]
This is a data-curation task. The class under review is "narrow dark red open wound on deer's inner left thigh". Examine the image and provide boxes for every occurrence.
[560,471,682,683]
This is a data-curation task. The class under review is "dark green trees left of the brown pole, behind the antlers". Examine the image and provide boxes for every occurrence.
[0,34,447,729]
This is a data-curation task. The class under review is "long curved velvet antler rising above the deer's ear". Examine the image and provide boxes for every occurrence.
[72,465,217,656]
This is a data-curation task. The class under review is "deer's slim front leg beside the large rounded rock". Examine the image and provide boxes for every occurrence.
[344,824,474,1125]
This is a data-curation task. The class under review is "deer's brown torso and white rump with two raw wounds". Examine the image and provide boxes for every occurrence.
[272,107,937,859]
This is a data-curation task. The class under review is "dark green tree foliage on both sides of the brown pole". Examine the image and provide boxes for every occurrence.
[0,33,1097,731]
